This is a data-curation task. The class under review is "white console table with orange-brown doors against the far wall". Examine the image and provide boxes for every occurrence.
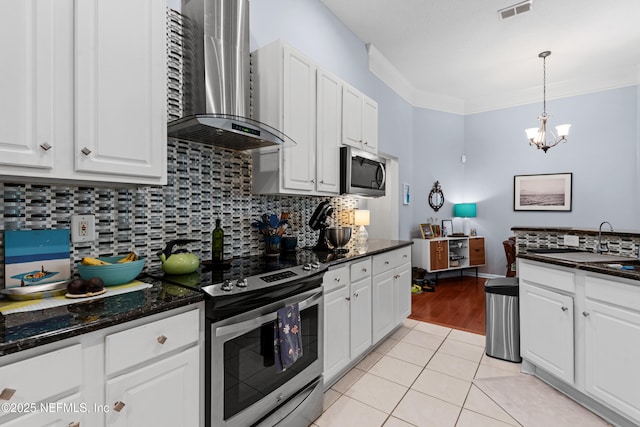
[411,236,486,281]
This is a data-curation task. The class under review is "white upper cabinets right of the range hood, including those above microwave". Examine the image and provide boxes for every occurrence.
[252,40,378,195]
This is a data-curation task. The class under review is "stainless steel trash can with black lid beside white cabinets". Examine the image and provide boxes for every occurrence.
[484,277,522,363]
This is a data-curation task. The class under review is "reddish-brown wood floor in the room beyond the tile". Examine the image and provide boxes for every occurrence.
[409,276,486,335]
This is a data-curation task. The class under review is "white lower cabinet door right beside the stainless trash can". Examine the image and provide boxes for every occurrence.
[520,284,574,384]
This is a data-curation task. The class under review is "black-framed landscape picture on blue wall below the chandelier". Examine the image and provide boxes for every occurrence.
[513,173,573,212]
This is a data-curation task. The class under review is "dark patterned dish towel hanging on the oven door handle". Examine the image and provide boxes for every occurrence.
[273,304,302,372]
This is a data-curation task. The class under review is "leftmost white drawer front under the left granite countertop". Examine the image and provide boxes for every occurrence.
[0,344,83,408]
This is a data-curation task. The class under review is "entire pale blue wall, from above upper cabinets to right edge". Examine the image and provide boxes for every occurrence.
[251,0,640,274]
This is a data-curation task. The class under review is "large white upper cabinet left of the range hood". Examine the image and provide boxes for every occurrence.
[0,0,167,184]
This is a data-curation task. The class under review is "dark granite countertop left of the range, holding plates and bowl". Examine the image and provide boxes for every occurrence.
[0,273,203,356]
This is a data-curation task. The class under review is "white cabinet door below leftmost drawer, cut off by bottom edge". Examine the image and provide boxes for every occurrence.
[2,394,85,427]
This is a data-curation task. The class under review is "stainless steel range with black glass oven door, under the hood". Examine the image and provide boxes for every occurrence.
[164,255,327,427]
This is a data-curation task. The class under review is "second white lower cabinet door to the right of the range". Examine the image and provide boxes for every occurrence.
[350,277,371,360]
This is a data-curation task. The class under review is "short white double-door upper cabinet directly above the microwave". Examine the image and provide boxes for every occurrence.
[342,84,378,153]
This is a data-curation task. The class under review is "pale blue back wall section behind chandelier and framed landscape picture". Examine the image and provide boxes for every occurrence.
[464,86,640,273]
